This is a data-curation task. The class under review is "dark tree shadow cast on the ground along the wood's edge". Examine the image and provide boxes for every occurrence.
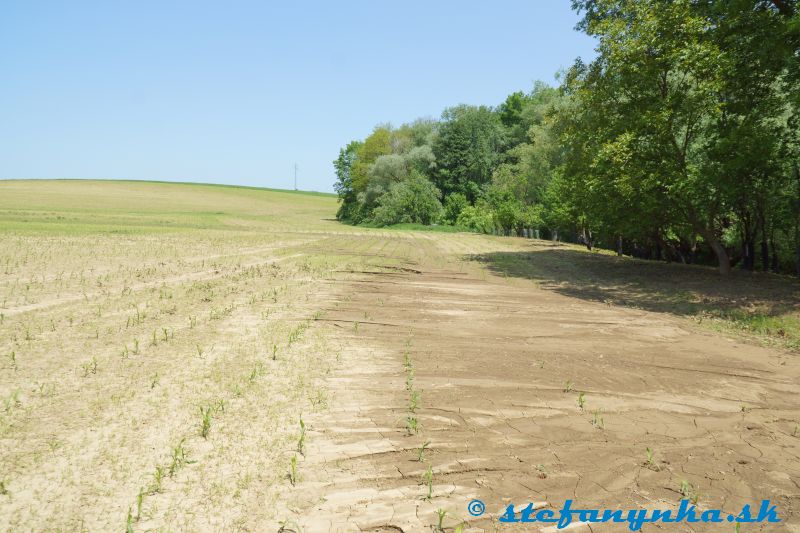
[469,241,800,316]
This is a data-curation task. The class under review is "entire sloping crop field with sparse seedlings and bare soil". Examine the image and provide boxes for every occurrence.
[0,181,800,532]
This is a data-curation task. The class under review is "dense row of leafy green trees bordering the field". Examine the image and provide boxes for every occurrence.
[334,0,800,275]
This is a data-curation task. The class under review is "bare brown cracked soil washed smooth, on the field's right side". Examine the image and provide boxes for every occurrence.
[285,239,800,532]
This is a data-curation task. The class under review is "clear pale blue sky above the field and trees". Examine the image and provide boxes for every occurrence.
[0,0,594,191]
